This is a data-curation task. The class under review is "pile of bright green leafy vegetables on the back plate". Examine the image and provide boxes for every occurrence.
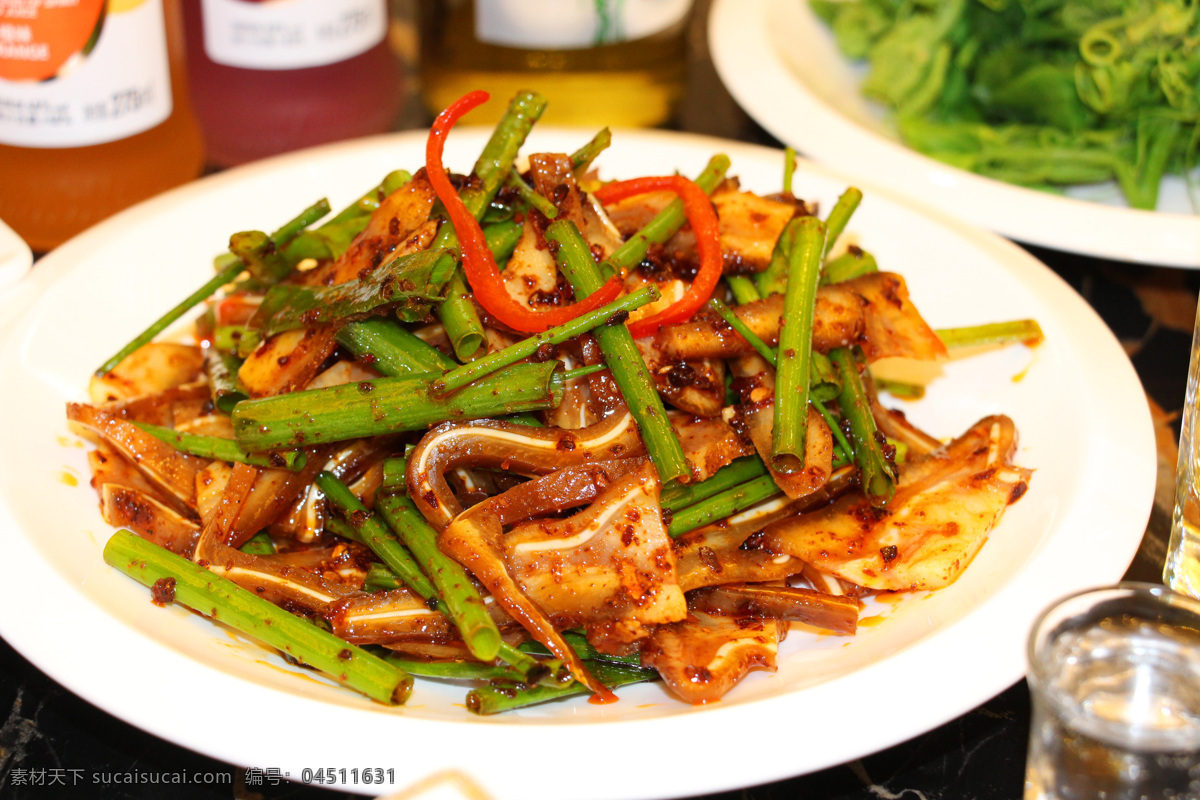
[810,0,1200,209]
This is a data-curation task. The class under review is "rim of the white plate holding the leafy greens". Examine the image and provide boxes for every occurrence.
[708,0,1200,269]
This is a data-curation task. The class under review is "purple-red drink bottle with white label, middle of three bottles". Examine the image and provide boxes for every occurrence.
[184,0,404,167]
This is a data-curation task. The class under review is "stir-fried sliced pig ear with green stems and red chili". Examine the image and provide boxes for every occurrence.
[67,92,1040,714]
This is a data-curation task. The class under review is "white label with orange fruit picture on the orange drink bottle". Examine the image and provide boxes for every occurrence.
[0,0,172,148]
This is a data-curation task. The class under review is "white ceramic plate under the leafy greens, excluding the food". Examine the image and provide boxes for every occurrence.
[708,0,1200,269]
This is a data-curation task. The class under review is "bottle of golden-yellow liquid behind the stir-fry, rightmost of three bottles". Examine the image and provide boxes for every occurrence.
[418,0,692,127]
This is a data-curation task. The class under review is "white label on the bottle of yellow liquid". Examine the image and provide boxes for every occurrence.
[475,0,691,50]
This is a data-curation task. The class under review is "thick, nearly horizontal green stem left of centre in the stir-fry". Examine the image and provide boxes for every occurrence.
[230,361,578,452]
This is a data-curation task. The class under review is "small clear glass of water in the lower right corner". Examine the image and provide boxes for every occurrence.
[1025,583,1200,800]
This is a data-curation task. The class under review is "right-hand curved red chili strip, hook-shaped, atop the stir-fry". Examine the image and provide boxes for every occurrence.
[594,175,722,338]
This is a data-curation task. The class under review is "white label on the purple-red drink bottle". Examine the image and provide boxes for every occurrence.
[198,0,388,70]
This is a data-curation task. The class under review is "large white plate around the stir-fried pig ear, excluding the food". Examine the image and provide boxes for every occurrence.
[0,130,1154,800]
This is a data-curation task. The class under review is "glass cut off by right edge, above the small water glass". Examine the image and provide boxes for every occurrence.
[1163,297,1200,597]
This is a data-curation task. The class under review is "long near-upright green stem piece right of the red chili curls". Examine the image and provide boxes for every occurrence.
[772,217,826,474]
